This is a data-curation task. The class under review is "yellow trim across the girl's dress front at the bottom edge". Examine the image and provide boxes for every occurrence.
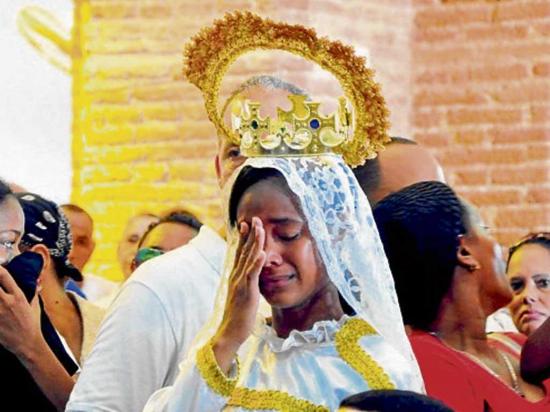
[227,388,329,412]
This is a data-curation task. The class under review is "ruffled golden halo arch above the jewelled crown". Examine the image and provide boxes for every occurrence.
[184,12,389,166]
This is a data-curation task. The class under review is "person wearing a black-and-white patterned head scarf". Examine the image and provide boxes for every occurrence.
[16,193,104,364]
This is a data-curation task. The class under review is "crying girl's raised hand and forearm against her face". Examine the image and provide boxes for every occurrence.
[212,217,266,372]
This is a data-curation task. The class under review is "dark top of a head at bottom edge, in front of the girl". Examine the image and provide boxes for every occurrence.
[340,390,458,412]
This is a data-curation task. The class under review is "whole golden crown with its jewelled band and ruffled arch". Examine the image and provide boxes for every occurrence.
[184,12,389,166]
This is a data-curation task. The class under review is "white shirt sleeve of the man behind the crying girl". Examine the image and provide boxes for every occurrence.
[66,282,178,412]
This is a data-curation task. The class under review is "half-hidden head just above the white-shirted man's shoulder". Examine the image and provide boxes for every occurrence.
[132,210,202,271]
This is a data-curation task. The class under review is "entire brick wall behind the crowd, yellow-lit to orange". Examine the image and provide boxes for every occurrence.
[73,0,550,279]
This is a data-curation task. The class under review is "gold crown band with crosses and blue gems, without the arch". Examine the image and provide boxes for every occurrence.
[231,94,351,157]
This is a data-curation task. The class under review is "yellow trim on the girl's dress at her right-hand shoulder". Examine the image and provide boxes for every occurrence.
[335,318,395,389]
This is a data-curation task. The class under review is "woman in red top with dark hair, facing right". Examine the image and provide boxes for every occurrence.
[374,182,550,412]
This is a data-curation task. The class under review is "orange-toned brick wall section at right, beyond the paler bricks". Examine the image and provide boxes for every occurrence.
[411,0,550,244]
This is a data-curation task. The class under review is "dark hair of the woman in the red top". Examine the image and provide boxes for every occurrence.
[373,181,471,330]
